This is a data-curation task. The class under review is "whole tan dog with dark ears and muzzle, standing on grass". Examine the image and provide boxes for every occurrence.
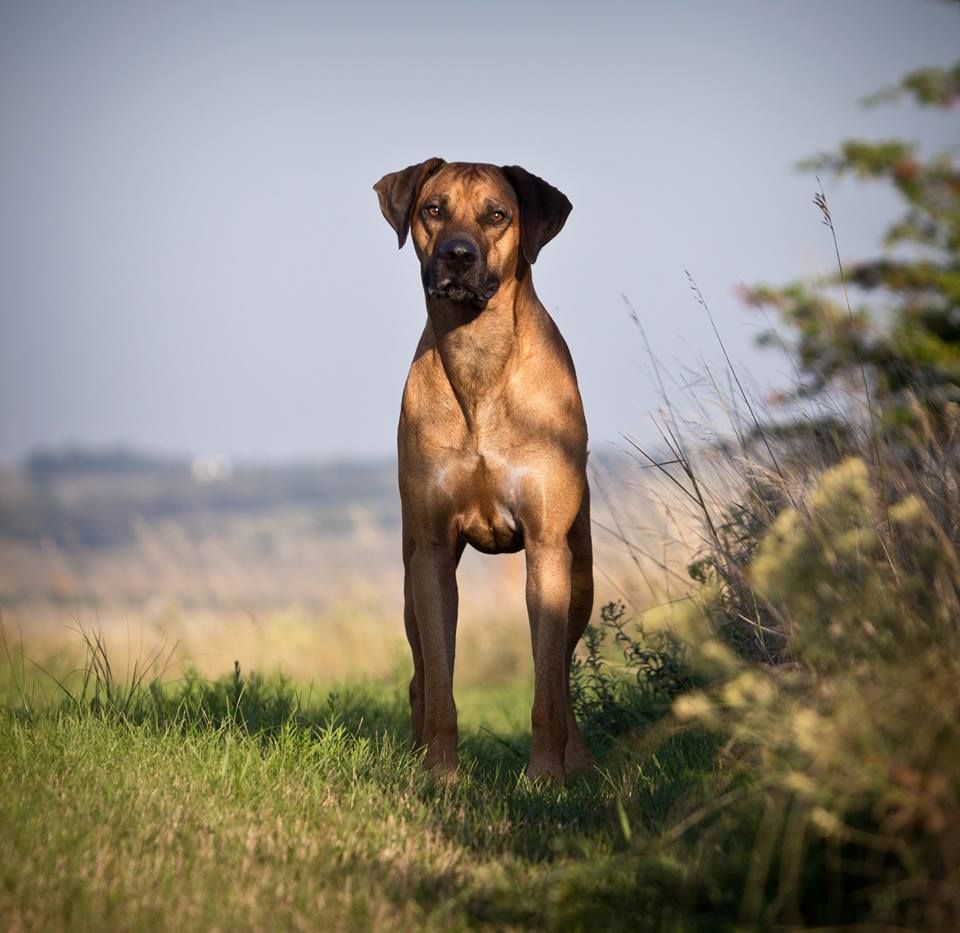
[374,158,593,781]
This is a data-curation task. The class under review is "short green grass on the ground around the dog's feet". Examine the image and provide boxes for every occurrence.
[0,660,718,930]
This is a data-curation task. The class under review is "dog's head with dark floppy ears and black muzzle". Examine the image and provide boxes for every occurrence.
[373,159,571,307]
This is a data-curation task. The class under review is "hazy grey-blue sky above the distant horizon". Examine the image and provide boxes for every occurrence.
[0,0,960,463]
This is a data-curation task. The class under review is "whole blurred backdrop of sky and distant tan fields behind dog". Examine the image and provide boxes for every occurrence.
[0,0,957,680]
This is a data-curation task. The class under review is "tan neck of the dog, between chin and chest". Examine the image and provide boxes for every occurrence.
[427,272,537,426]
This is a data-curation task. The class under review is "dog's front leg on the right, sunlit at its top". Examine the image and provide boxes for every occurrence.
[527,539,571,781]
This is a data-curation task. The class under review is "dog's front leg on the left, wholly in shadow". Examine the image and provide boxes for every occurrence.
[410,544,458,771]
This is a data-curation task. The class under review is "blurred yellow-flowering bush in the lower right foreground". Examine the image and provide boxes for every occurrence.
[675,459,960,929]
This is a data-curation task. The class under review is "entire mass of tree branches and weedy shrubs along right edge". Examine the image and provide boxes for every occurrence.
[644,29,960,930]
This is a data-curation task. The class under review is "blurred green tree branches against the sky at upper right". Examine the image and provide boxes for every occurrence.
[744,55,960,420]
